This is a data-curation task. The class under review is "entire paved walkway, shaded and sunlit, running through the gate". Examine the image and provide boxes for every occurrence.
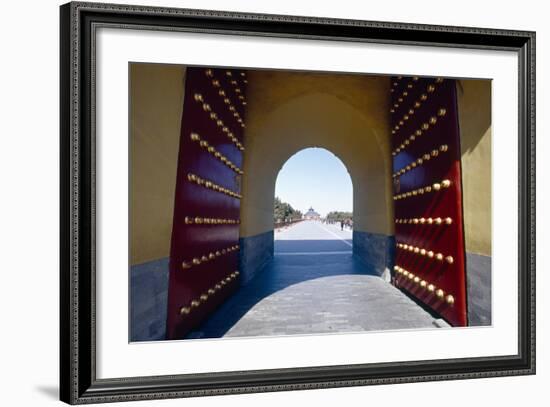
[188,221,446,338]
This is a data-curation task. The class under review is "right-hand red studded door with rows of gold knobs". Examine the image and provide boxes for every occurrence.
[390,77,468,326]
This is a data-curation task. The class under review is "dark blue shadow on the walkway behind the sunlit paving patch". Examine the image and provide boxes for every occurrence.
[186,240,378,339]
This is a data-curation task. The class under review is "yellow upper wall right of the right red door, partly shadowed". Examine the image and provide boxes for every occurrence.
[457,80,491,256]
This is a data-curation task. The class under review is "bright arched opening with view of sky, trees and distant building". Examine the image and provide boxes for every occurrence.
[273,147,353,255]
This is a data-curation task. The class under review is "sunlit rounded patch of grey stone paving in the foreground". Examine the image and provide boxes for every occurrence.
[225,275,440,336]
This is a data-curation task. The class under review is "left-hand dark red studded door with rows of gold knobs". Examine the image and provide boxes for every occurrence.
[167,68,247,339]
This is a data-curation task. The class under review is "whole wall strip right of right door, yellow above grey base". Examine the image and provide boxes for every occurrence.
[457,79,492,326]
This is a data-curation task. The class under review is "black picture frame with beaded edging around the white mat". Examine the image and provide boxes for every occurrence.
[60,2,535,404]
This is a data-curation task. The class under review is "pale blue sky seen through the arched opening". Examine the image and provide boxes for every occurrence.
[275,148,353,216]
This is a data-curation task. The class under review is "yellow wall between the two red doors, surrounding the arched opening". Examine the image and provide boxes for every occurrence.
[241,71,393,237]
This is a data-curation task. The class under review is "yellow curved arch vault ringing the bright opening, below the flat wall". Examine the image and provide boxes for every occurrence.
[241,93,392,236]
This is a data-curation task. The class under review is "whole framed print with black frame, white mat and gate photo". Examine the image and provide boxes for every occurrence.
[60,3,535,404]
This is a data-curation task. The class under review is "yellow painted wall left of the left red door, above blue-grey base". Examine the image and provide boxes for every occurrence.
[130,64,185,265]
